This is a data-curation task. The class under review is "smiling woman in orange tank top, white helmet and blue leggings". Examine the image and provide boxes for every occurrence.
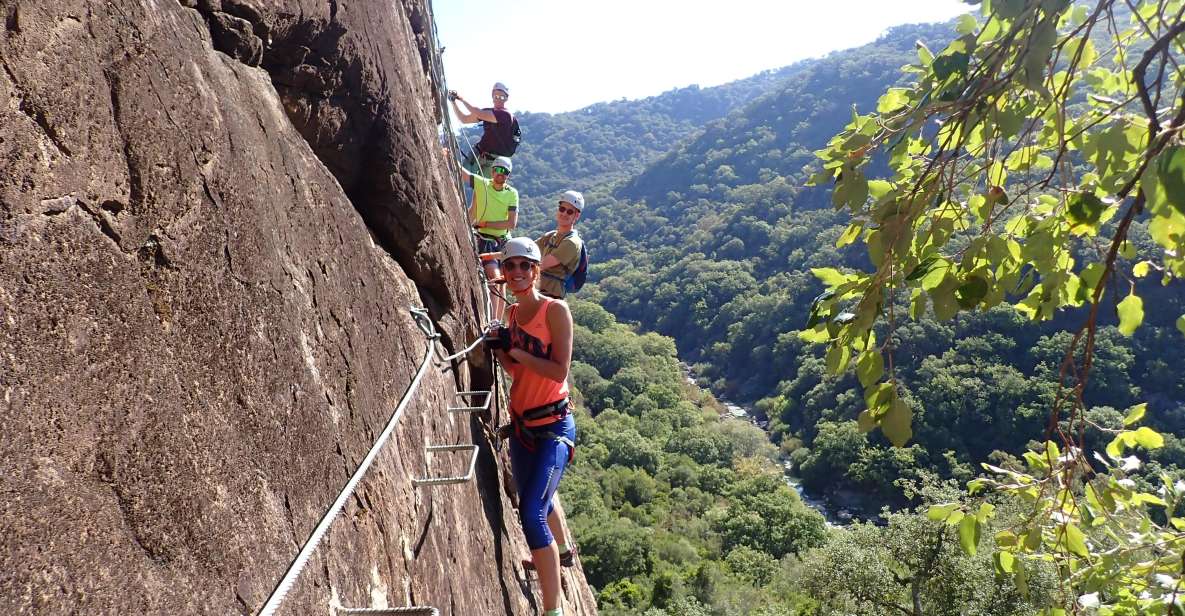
[486,238,576,616]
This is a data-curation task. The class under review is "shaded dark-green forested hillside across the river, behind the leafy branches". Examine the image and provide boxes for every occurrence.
[526,16,1185,512]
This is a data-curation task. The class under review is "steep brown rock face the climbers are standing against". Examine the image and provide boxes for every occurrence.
[0,0,596,615]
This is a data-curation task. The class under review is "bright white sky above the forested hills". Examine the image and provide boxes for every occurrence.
[433,0,975,113]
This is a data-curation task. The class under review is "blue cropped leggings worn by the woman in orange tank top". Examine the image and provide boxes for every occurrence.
[510,415,576,550]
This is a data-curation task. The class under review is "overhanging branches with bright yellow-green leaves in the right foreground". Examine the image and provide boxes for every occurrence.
[802,0,1185,614]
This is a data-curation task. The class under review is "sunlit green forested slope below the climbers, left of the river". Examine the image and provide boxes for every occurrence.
[562,300,1053,616]
